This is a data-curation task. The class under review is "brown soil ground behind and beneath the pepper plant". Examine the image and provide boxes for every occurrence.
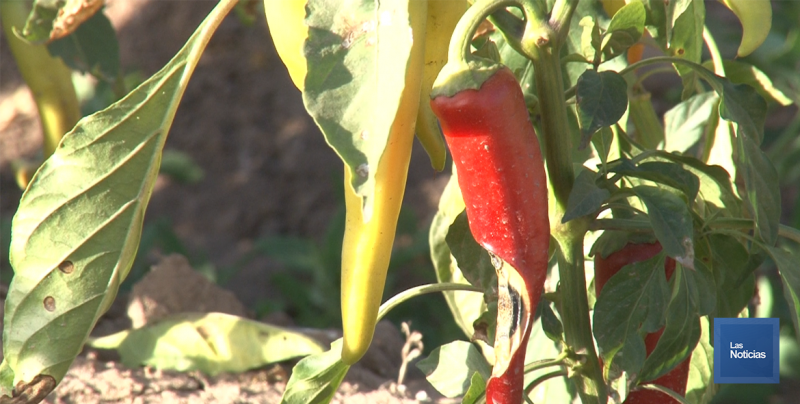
[0,0,447,403]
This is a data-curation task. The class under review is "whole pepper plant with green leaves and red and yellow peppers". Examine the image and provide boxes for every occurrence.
[0,0,800,404]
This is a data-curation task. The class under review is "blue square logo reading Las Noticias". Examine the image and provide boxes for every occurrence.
[714,318,780,384]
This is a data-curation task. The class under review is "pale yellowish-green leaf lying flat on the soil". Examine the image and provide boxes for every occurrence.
[89,313,324,376]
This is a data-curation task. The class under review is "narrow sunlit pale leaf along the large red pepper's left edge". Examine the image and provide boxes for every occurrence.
[428,167,483,337]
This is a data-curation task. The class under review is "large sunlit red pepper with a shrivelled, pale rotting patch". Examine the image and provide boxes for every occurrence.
[431,67,550,404]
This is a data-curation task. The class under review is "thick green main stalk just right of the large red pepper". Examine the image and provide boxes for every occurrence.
[522,0,607,404]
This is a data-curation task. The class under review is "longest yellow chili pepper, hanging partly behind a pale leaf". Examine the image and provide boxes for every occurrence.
[342,0,427,364]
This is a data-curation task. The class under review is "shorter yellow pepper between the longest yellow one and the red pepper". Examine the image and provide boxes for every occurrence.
[417,0,469,171]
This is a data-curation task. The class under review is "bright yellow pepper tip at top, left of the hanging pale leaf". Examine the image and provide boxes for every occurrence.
[264,0,308,91]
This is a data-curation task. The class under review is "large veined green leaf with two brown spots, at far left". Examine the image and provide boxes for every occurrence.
[0,1,236,394]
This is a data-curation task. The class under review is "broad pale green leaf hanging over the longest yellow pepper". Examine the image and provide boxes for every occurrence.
[303,0,419,219]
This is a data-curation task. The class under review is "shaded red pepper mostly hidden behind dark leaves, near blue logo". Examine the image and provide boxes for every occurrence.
[594,242,692,404]
